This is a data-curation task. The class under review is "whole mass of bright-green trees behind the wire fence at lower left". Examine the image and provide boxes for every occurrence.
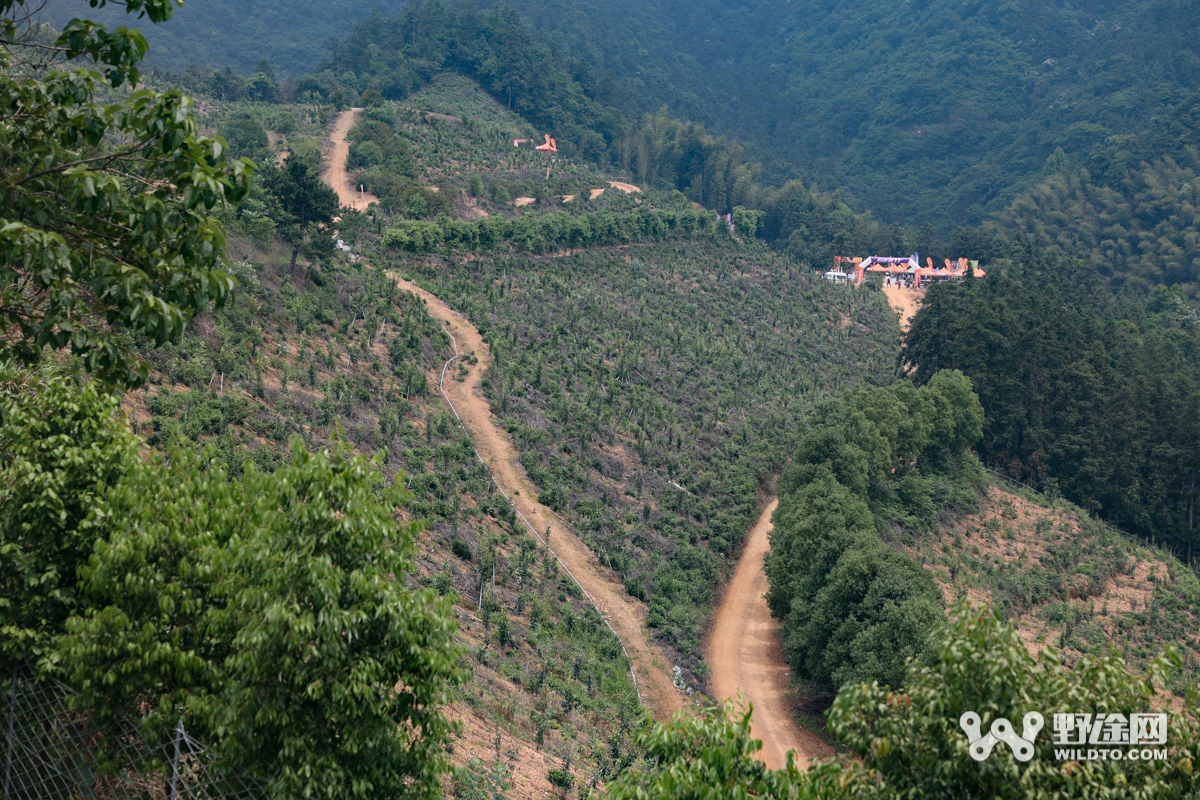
[0,367,463,798]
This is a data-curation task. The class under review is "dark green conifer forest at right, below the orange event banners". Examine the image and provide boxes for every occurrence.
[905,248,1200,561]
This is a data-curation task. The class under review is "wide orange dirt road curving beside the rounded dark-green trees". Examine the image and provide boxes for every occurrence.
[708,500,833,769]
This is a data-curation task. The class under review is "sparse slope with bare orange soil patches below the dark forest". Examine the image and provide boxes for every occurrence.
[906,486,1200,664]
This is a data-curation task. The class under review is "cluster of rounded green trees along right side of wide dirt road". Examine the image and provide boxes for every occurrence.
[767,372,983,686]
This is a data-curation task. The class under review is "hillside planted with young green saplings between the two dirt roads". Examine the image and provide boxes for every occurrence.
[396,241,896,679]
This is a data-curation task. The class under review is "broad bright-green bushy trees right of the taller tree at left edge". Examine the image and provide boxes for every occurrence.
[60,441,462,798]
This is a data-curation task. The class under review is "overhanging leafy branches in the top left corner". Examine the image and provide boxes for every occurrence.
[0,0,253,387]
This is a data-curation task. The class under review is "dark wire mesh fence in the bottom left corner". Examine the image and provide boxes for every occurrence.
[0,666,266,800]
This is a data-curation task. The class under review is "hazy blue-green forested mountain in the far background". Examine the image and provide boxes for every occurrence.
[48,0,1200,242]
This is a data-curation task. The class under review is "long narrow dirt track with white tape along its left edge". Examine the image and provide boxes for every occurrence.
[392,276,686,721]
